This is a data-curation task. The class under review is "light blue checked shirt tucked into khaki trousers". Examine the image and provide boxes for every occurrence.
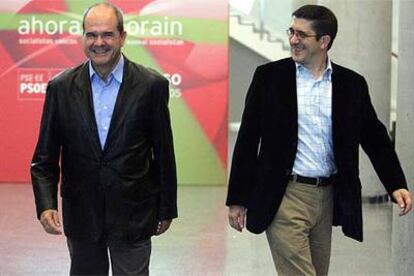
[293,59,337,177]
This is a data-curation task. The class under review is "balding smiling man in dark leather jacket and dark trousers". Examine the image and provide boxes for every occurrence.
[31,3,177,275]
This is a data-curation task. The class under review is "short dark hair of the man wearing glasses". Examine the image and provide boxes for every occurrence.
[292,5,338,50]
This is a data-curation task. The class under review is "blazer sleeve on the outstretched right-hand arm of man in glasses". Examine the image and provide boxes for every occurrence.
[360,77,407,195]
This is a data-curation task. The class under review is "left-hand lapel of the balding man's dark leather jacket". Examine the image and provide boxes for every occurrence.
[74,62,102,158]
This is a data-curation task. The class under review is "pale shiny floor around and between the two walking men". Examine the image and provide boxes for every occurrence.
[0,184,392,276]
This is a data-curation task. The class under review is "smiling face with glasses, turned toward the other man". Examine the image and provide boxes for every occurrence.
[289,17,326,66]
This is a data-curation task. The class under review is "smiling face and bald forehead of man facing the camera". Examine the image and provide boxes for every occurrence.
[83,6,126,72]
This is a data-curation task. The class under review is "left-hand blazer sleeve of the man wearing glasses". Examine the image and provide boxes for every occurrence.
[226,67,262,207]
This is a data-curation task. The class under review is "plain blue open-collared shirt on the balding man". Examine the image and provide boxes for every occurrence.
[89,55,124,149]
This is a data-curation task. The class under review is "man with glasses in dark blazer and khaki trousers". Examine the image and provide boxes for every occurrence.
[226,5,411,275]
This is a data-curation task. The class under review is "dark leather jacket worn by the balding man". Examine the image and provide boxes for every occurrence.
[31,58,177,242]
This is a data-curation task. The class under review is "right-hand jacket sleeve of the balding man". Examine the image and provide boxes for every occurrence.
[152,79,177,220]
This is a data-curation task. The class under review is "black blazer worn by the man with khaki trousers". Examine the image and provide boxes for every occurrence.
[226,58,406,241]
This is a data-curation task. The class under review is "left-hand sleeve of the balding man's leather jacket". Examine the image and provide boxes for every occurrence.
[31,79,60,218]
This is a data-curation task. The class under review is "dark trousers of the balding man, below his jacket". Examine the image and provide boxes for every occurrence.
[67,238,151,275]
